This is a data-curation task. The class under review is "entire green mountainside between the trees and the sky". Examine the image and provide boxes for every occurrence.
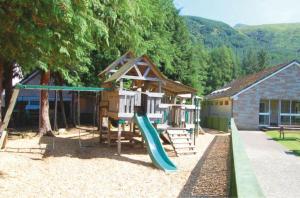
[185,16,300,64]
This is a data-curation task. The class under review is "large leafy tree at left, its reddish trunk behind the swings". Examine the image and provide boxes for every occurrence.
[0,0,108,133]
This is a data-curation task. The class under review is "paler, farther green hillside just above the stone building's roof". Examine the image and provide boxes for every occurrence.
[236,23,300,63]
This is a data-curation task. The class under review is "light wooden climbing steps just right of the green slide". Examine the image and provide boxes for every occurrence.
[167,129,196,156]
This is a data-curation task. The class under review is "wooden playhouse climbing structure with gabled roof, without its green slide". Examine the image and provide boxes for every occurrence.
[98,52,200,155]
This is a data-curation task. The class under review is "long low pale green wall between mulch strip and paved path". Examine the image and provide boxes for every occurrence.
[230,118,264,197]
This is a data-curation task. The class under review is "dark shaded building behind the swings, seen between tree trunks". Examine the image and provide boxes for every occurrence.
[10,70,96,127]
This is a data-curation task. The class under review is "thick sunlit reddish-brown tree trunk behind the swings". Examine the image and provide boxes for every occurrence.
[39,71,54,136]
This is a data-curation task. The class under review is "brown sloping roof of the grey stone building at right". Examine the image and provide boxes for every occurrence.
[205,60,300,99]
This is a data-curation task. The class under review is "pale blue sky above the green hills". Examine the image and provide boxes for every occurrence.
[174,0,300,26]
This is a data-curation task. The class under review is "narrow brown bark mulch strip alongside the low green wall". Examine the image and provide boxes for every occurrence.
[179,135,231,197]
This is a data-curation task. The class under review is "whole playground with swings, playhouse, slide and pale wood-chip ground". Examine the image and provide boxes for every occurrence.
[0,52,220,197]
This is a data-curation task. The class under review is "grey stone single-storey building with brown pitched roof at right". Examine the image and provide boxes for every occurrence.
[202,61,300,129]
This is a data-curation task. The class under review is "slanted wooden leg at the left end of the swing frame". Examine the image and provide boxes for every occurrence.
[0,89,20,149]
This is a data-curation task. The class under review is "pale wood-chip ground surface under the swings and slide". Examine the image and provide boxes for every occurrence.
[0,128,214,198]
